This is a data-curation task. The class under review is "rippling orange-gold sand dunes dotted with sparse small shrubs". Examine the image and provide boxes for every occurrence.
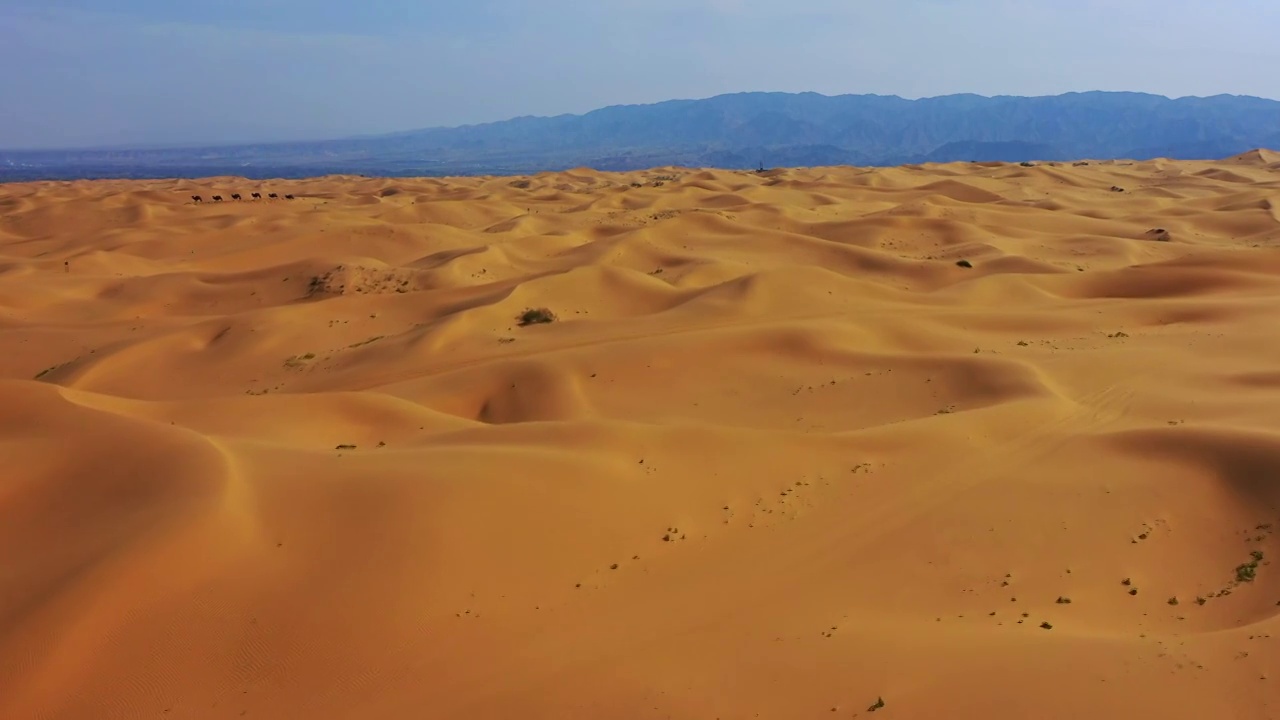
[0,151,1280,720]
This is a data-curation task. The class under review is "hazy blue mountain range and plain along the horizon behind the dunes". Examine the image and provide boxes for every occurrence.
[0,92,1280,181]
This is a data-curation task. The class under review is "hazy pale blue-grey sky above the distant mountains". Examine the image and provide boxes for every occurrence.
[0,0,1280,149]
